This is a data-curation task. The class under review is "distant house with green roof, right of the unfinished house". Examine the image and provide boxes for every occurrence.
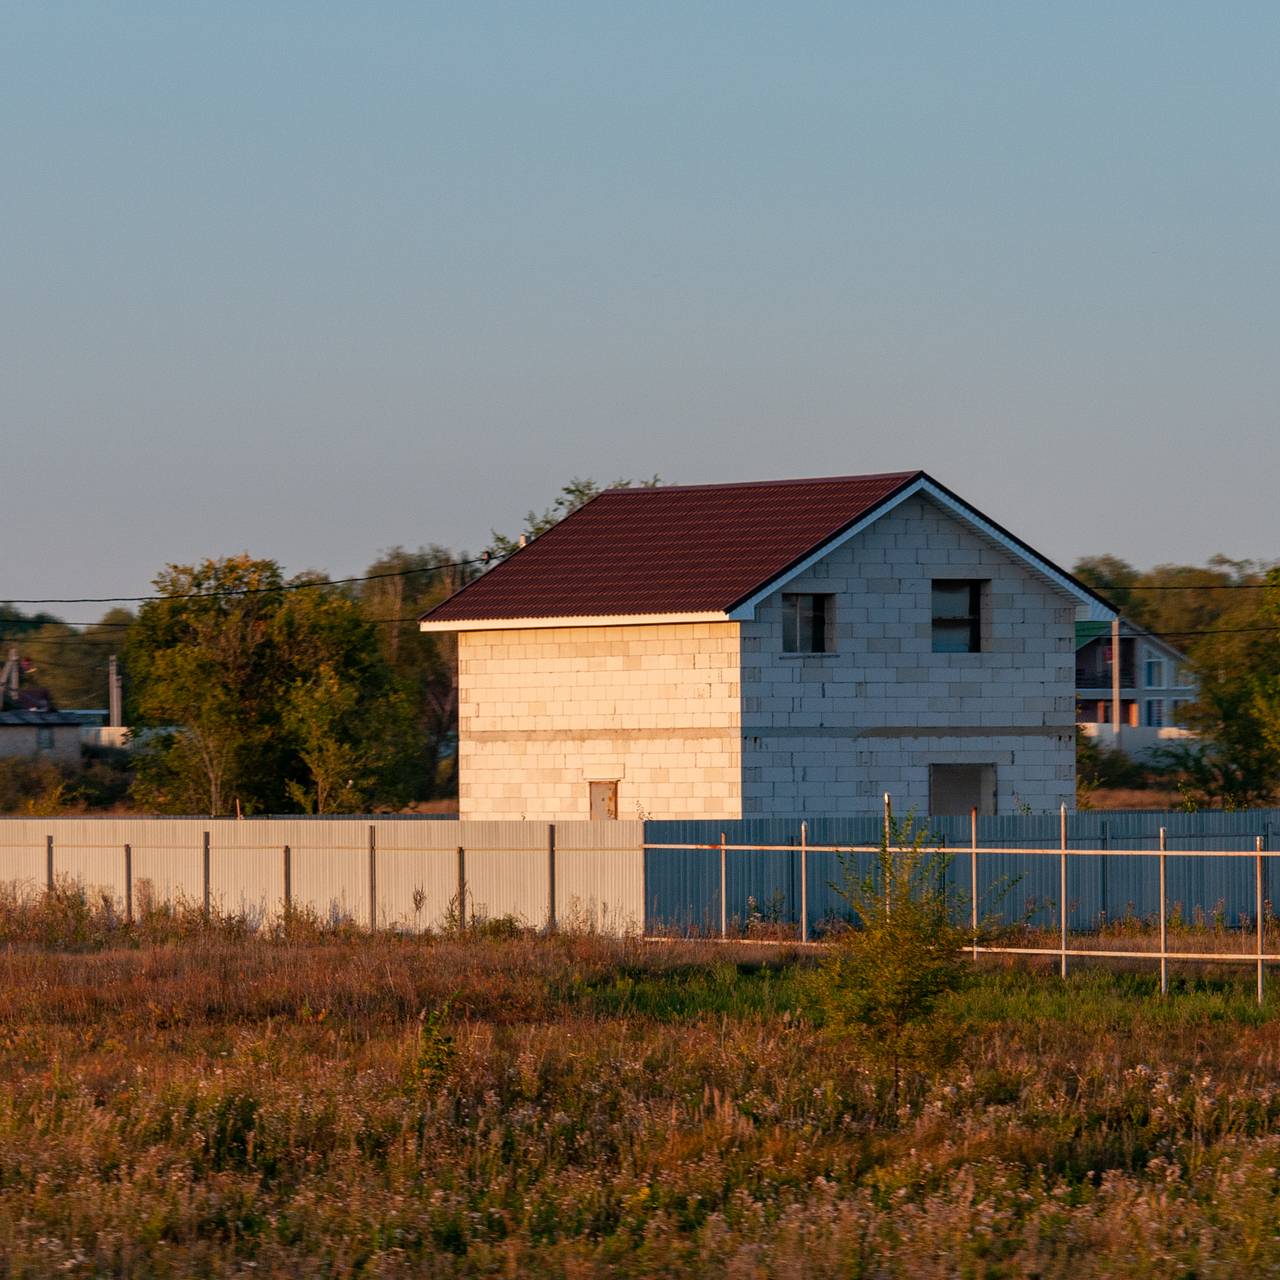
[1075,620,1199,759]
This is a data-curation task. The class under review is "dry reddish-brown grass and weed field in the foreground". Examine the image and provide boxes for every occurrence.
[0,904,1280,1280]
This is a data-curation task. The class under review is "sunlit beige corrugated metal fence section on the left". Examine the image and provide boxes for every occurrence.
[0,818,644,932]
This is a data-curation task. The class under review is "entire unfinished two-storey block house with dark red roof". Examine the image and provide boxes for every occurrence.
[421,471,1115,819]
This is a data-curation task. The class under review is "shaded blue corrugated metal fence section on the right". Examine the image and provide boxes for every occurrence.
[644,809,1280,933]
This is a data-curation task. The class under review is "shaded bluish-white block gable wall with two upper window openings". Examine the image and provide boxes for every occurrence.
[742,497,1075,815]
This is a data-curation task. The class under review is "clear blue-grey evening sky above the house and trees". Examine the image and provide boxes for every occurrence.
[0,0,1280,604]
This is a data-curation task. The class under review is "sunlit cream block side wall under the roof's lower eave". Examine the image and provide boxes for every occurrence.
[458,622,742,820]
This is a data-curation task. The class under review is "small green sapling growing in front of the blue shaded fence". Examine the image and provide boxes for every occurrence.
[817,818,973,1110]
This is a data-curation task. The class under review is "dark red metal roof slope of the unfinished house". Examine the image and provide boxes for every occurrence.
[422,471,923,622]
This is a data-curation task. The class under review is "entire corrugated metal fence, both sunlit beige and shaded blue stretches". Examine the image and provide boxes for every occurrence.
[0,809,1280,933]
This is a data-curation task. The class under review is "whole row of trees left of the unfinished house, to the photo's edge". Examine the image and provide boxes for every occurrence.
[0,545,474,814]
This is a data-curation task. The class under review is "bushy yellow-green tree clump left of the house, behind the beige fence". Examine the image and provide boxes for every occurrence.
[129,556,407,814]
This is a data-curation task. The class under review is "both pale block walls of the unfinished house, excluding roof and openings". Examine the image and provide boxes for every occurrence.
[458,497,1075,819]
